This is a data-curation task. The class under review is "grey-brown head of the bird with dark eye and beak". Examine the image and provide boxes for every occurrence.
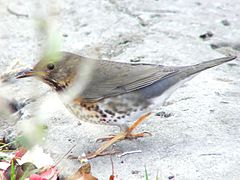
[16,52,80,91]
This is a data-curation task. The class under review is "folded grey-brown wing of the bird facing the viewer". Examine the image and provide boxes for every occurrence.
[81,61,177,101]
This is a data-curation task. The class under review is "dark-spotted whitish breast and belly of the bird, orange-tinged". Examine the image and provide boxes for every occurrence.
[62,93,152,126]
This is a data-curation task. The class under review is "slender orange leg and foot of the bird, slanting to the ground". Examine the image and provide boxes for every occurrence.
[83,113,151,159]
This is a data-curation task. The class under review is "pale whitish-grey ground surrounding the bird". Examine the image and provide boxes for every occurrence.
[0,0,240,180]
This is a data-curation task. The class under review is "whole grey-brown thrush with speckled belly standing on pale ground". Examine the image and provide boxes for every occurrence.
[16,52,236,158]
